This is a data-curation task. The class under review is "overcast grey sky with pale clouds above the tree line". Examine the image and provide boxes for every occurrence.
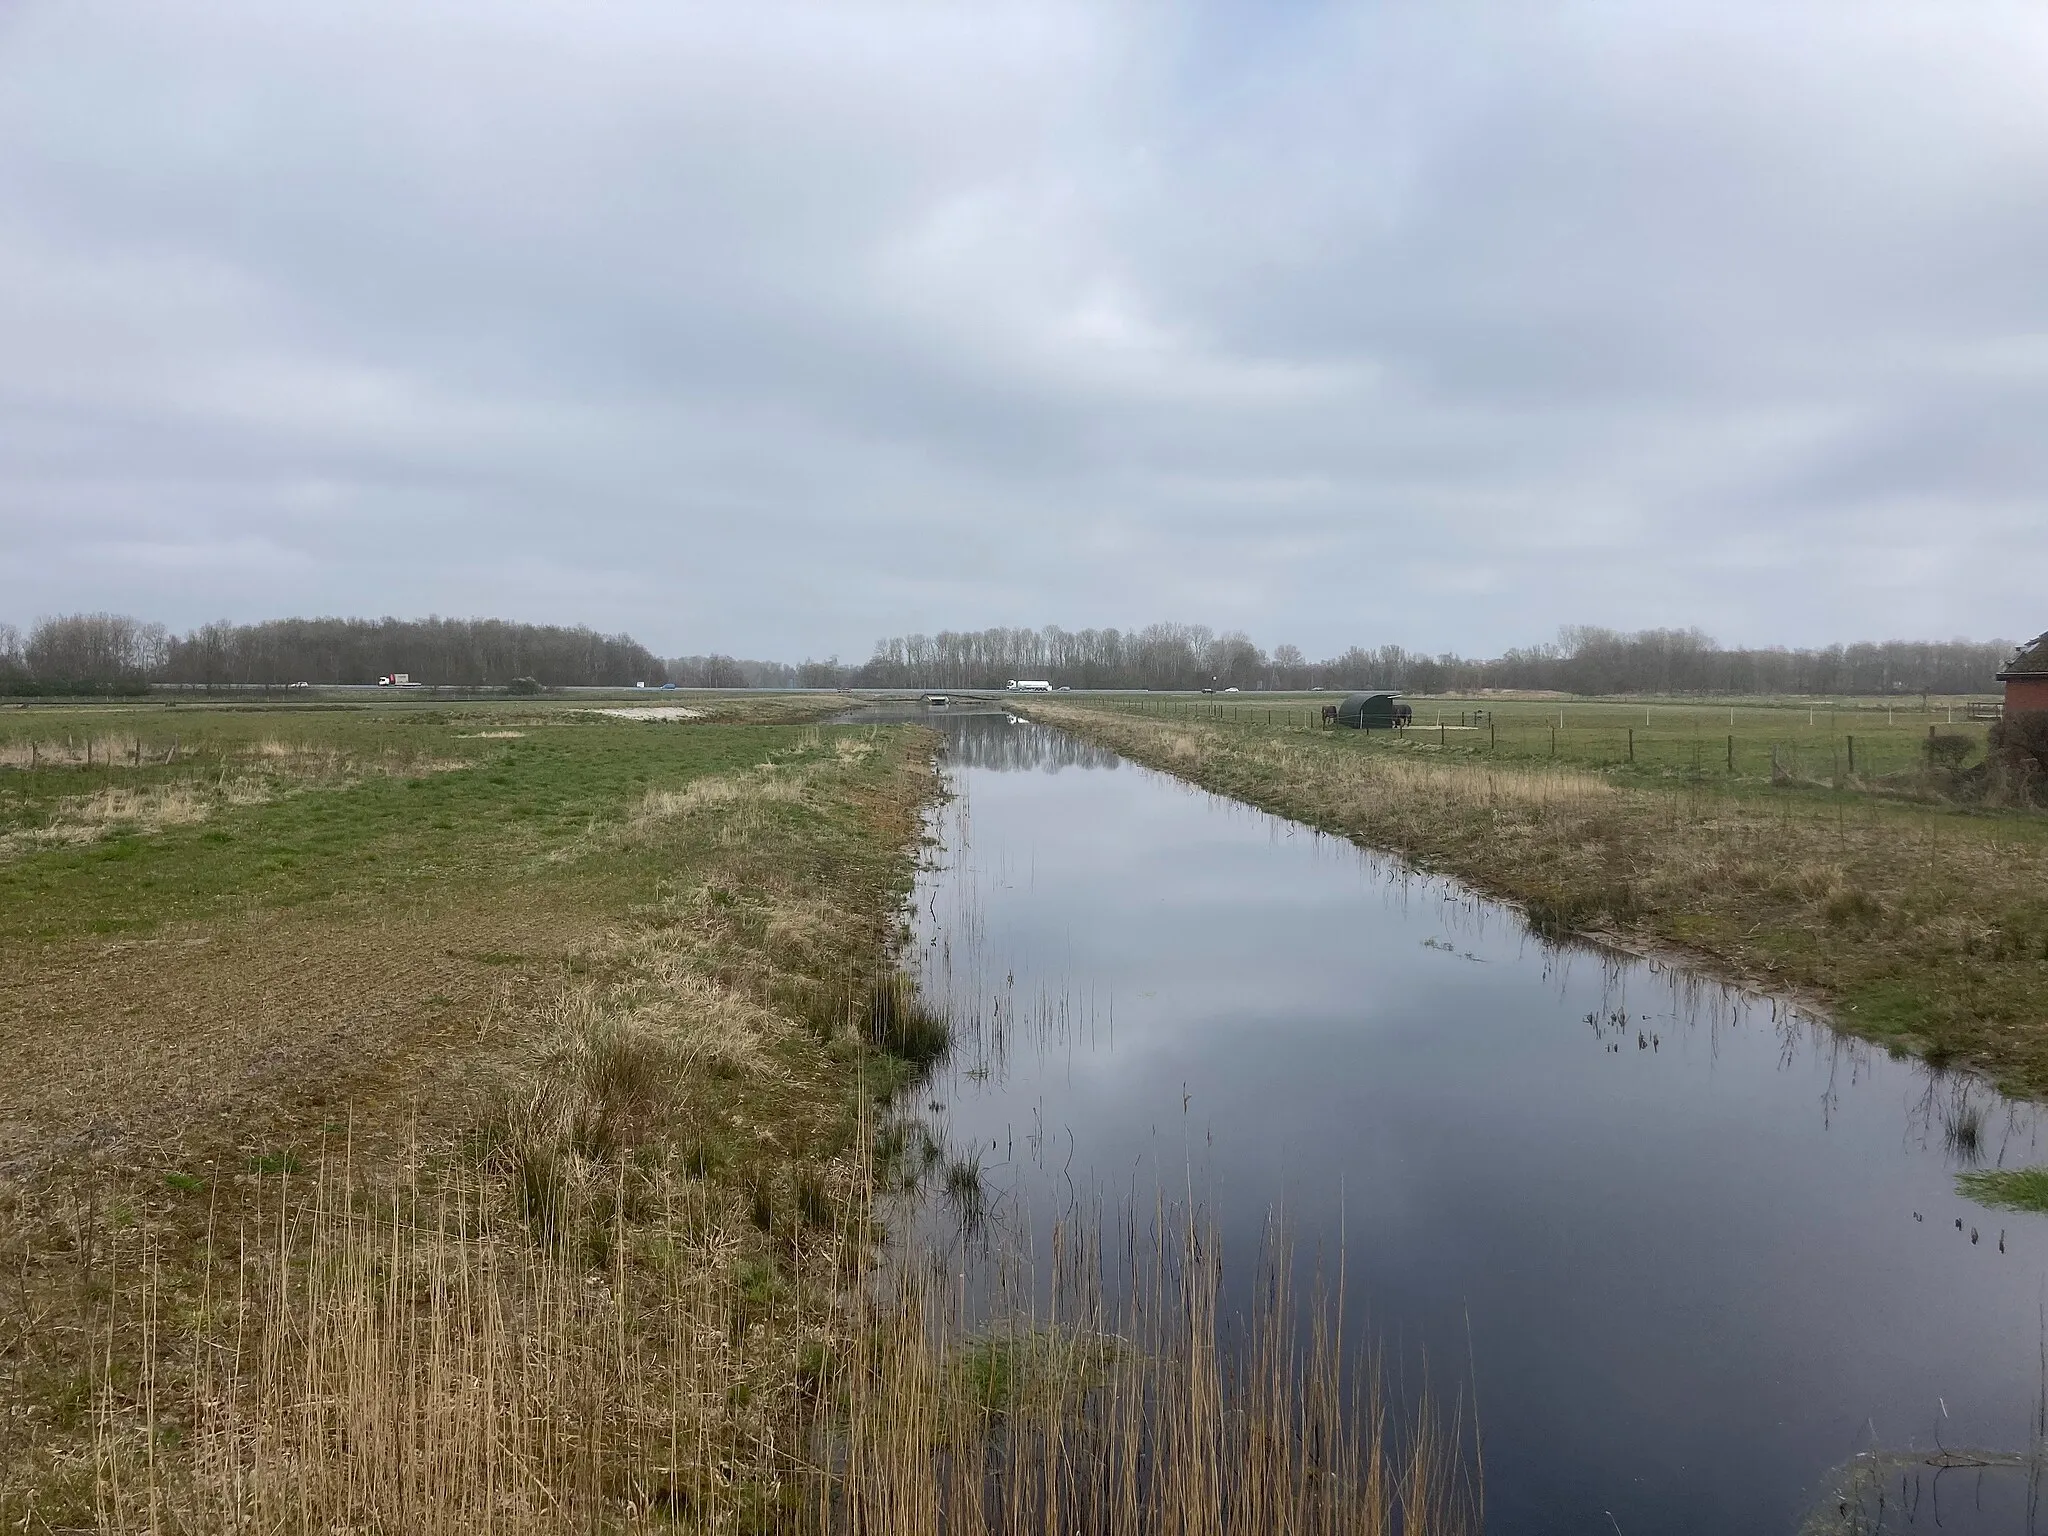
[0,0,2048,659]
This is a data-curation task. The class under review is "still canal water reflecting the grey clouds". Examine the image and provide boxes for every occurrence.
[884,715,2048,1536]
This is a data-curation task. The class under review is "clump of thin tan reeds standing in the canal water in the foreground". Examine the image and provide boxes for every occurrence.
[839,1210,1483,1536]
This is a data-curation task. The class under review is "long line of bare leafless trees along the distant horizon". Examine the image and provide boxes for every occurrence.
[0,612,2013,694]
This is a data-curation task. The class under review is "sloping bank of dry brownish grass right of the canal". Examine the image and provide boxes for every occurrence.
[1026,700,2048,1096]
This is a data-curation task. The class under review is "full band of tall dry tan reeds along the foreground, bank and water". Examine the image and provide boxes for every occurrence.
[96,1157,1481,1536]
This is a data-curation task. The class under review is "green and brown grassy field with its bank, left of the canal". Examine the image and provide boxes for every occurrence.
[0,696,932,1530]
